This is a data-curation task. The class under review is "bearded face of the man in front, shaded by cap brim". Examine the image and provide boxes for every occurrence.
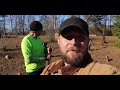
[58,28,89,65]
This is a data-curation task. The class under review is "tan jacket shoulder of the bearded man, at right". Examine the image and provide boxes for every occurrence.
[76,61,120,75]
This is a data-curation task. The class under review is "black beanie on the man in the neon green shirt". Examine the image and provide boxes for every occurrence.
[30,21,43,32]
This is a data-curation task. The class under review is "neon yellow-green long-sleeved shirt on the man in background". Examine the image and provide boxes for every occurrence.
[21,34,45,72]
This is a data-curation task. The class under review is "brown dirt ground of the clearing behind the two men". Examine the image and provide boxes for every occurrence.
[0,36,120,75]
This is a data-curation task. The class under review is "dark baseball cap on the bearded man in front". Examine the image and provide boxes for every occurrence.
[59,17,89,37]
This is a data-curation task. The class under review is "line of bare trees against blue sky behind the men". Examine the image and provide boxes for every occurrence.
[0,15,120,39]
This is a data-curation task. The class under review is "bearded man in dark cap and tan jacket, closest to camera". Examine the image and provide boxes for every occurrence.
[41,17,119,75]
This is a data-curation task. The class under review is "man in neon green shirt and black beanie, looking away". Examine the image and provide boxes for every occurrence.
[21,21,46,75]
